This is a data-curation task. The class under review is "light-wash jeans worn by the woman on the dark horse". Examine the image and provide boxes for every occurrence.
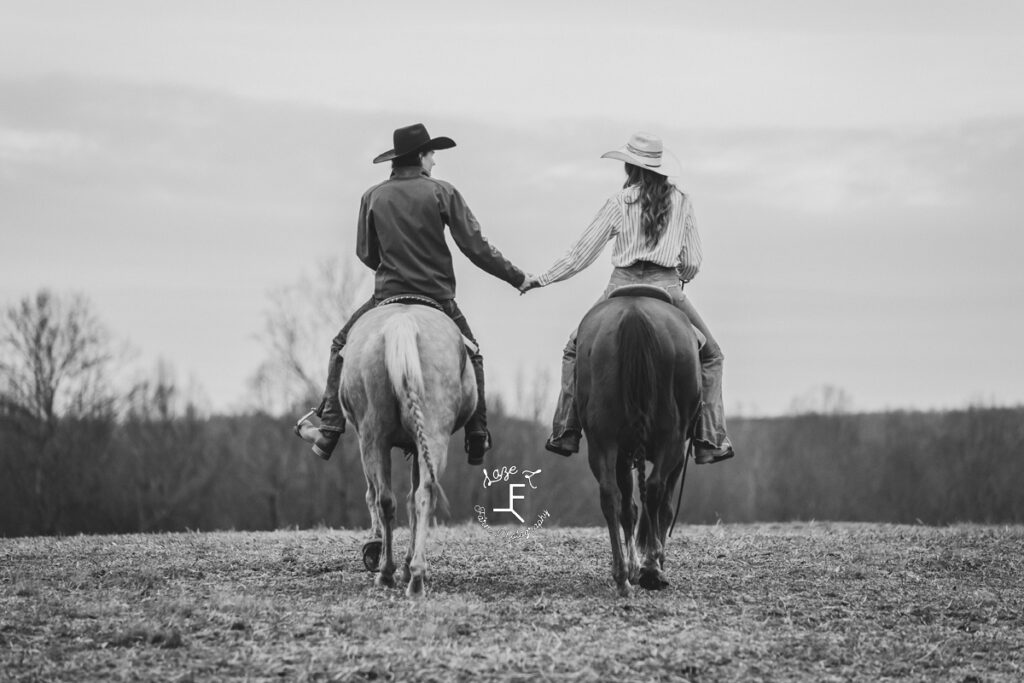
[551,261,729,449]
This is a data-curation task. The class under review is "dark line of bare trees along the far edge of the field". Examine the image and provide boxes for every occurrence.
[0,291,1024,536]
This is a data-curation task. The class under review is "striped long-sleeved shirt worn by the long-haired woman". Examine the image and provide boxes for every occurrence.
[538,185,701,287]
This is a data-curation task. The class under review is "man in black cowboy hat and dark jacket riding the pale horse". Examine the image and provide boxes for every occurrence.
[297,124,526,465]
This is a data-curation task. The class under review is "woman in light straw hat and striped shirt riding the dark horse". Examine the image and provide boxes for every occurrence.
[519,133,734,464]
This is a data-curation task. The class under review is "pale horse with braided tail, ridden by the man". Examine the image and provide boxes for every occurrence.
[341,303,477,597]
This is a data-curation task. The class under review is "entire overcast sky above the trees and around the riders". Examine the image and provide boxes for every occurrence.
[0,0,1024,415]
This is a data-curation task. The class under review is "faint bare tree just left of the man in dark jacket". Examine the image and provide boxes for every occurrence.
[251,259,371,413]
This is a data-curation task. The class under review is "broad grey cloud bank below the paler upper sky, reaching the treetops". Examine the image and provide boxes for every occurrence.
[0,79,1024,412]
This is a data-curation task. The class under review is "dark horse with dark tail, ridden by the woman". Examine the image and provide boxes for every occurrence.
[577,286,700,596]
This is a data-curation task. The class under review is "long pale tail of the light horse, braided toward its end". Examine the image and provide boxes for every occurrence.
[384,315,449,515]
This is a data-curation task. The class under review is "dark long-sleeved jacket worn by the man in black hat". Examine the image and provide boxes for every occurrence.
[355,167,525,301]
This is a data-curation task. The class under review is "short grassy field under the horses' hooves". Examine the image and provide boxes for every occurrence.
[0,523,1024,682]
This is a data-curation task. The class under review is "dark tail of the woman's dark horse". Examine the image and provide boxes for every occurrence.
[617,308,658,462]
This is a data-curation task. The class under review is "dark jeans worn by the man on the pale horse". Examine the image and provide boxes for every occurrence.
[319,297,487,434]
